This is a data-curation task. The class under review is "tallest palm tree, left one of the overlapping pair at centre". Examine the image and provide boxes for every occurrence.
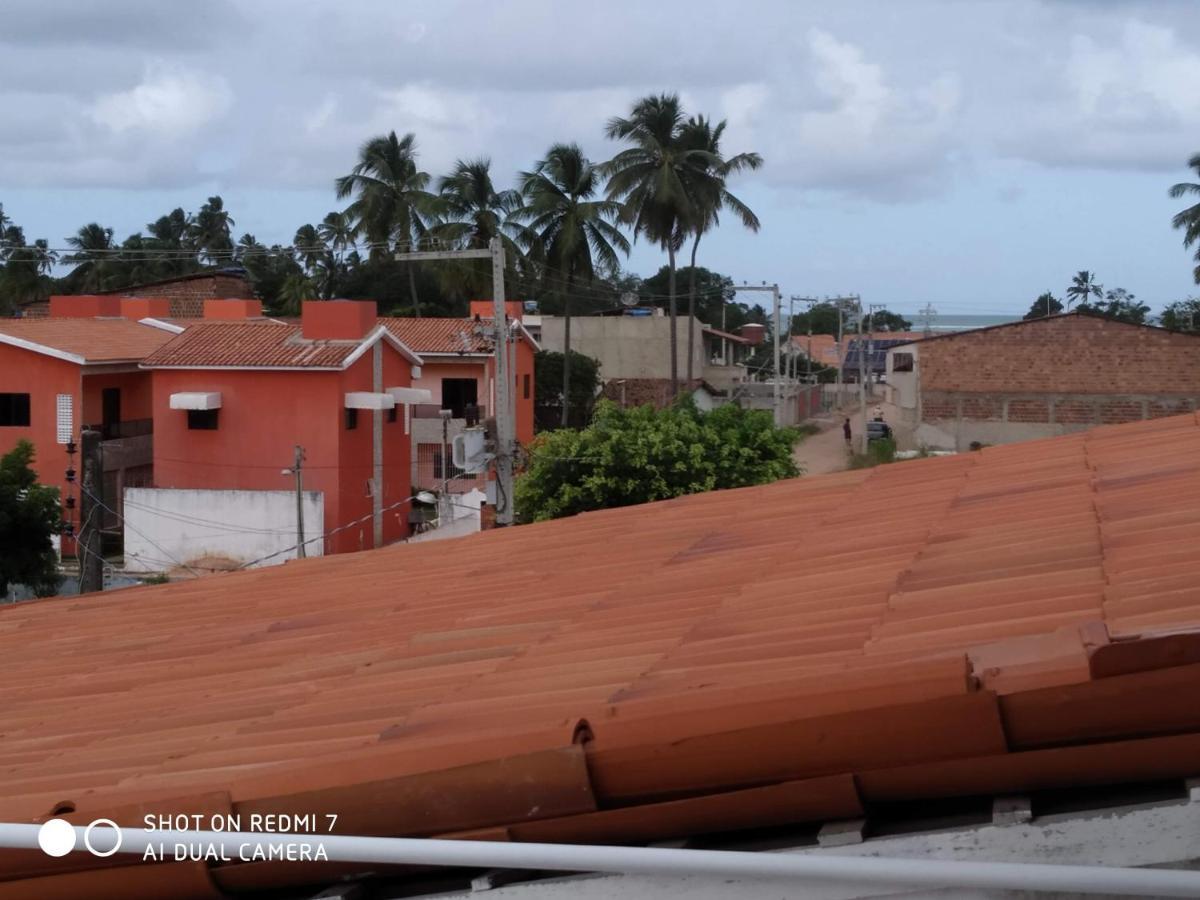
[605,94,720,392]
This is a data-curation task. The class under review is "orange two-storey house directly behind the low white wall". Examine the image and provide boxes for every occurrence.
[142,300,422,553]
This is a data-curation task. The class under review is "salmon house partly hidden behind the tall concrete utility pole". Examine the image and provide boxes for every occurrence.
[382,300,540,491]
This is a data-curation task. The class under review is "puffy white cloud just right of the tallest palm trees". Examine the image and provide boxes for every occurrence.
[721,29,961,199]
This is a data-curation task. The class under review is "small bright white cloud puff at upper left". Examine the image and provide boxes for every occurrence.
[89,62,233,138]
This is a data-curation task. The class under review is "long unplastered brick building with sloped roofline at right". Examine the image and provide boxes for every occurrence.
[887,313,1200,450]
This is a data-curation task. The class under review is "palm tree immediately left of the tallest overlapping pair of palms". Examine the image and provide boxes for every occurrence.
[512,144,630,428]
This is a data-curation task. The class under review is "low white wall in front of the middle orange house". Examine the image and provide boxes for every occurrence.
[125,487,325,572]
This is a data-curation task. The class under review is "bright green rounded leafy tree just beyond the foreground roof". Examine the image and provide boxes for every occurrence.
[516,396,799,522]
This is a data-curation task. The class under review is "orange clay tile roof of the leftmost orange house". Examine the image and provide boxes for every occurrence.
[0,318,173,365]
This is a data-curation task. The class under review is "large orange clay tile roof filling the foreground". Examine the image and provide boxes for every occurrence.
[0,415,1200,896]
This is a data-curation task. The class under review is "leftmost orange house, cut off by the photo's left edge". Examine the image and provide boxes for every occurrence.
[0,296,172,552]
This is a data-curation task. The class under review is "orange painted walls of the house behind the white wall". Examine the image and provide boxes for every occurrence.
[152,347,410,553]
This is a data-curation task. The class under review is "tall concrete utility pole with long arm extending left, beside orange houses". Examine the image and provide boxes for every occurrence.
[394,238,516,527]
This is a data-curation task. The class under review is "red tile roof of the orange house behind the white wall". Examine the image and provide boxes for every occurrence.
[143,319,419,368]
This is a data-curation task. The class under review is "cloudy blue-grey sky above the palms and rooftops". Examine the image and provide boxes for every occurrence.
[0,0,1200,313]
